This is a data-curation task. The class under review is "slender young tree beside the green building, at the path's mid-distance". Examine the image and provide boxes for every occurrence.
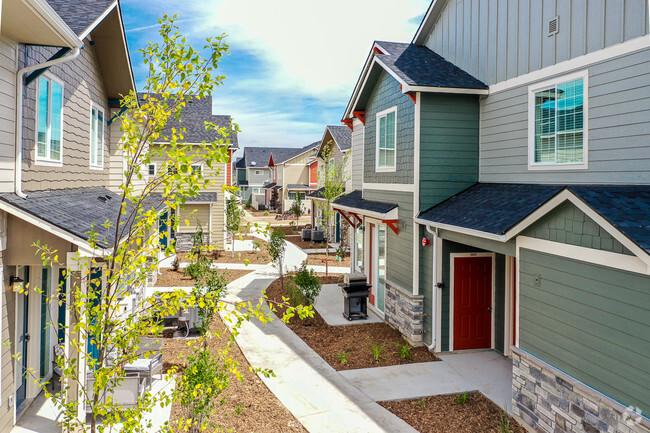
[316,140,348,275]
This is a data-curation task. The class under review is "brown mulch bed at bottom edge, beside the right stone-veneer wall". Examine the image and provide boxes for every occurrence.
[379,392,526,433]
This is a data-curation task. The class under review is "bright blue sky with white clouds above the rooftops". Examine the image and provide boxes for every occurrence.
[121,0,430,147]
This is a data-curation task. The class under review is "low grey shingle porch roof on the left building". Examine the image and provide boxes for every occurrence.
[0,188,132,248]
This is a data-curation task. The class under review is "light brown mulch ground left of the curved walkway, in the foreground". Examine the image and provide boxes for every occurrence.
[163,316,307,433]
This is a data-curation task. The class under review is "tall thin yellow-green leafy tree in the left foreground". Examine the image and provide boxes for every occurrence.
[31,15,309,433]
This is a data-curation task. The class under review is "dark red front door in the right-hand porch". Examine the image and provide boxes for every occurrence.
[454,257,492,350]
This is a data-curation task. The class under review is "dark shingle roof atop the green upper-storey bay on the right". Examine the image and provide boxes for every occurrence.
[376,41,488,89]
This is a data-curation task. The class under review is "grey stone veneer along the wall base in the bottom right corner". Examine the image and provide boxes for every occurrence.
[512,347,650,433]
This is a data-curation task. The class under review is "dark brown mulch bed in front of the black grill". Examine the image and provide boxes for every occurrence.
[266,276,436,370]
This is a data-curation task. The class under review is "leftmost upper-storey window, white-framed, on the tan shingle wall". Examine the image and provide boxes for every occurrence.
[36,76,63,165]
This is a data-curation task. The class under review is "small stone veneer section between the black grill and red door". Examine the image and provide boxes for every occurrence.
[384,281,424,345]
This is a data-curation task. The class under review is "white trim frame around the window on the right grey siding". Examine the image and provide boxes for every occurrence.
[528,69,589,170]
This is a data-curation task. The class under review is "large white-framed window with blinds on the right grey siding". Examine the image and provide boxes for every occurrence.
[528,72,587,169]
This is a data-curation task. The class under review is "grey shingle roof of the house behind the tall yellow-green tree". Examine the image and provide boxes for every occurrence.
[138,93,238,147]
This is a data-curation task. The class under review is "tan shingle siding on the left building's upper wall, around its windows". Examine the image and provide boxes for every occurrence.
[19,44,109,191]
